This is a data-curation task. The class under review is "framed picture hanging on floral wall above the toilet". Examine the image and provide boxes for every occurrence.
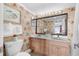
[3,6,21,24]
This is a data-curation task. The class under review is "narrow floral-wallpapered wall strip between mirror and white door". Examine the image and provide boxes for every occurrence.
[64,8,75,42]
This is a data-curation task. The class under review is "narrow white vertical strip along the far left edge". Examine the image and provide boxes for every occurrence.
[0,3,3,56]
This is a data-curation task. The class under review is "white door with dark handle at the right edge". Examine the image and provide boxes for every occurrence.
[71,4,79,56]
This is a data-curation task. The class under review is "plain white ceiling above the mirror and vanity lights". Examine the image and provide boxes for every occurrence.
[22,3,76,14]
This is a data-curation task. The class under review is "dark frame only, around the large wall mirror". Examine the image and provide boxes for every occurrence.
[33,13,68,36]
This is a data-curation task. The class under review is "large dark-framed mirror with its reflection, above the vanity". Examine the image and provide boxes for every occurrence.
[33,13,68,35]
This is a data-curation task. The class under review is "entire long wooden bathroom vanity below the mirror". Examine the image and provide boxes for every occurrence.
[29,37,70,56]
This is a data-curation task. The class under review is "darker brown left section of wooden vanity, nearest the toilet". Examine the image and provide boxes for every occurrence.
[29,38,45,55]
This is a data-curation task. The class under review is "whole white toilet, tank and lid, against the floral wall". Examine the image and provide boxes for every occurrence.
[4,39,31,56]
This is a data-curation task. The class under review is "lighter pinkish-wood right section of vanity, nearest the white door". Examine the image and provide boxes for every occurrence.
[45,40,70,56]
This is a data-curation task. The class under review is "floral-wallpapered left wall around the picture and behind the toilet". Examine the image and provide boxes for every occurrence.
[4,3,33,50]
